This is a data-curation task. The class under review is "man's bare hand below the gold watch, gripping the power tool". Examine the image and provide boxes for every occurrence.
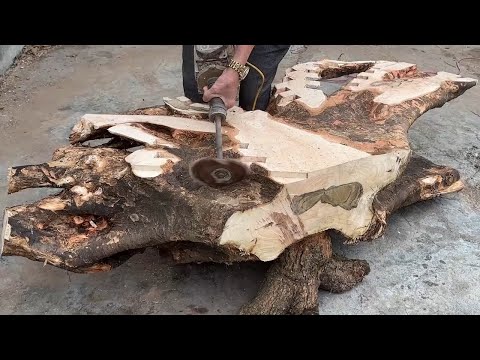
[203,68,240,109]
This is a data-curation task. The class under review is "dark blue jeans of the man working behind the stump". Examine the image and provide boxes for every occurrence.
[182,45,290,111]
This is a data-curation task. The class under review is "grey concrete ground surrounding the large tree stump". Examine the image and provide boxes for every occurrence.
[0,45,480,314]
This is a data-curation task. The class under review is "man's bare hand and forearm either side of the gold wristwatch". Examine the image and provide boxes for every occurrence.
[203,45,255,109]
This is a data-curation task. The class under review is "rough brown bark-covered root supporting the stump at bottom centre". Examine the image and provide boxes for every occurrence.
[240,232,370,315]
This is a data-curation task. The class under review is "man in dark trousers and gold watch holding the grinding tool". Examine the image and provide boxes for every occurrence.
[182,45,290,111]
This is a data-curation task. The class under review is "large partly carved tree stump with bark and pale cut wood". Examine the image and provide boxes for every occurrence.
[0,60,477,314]
